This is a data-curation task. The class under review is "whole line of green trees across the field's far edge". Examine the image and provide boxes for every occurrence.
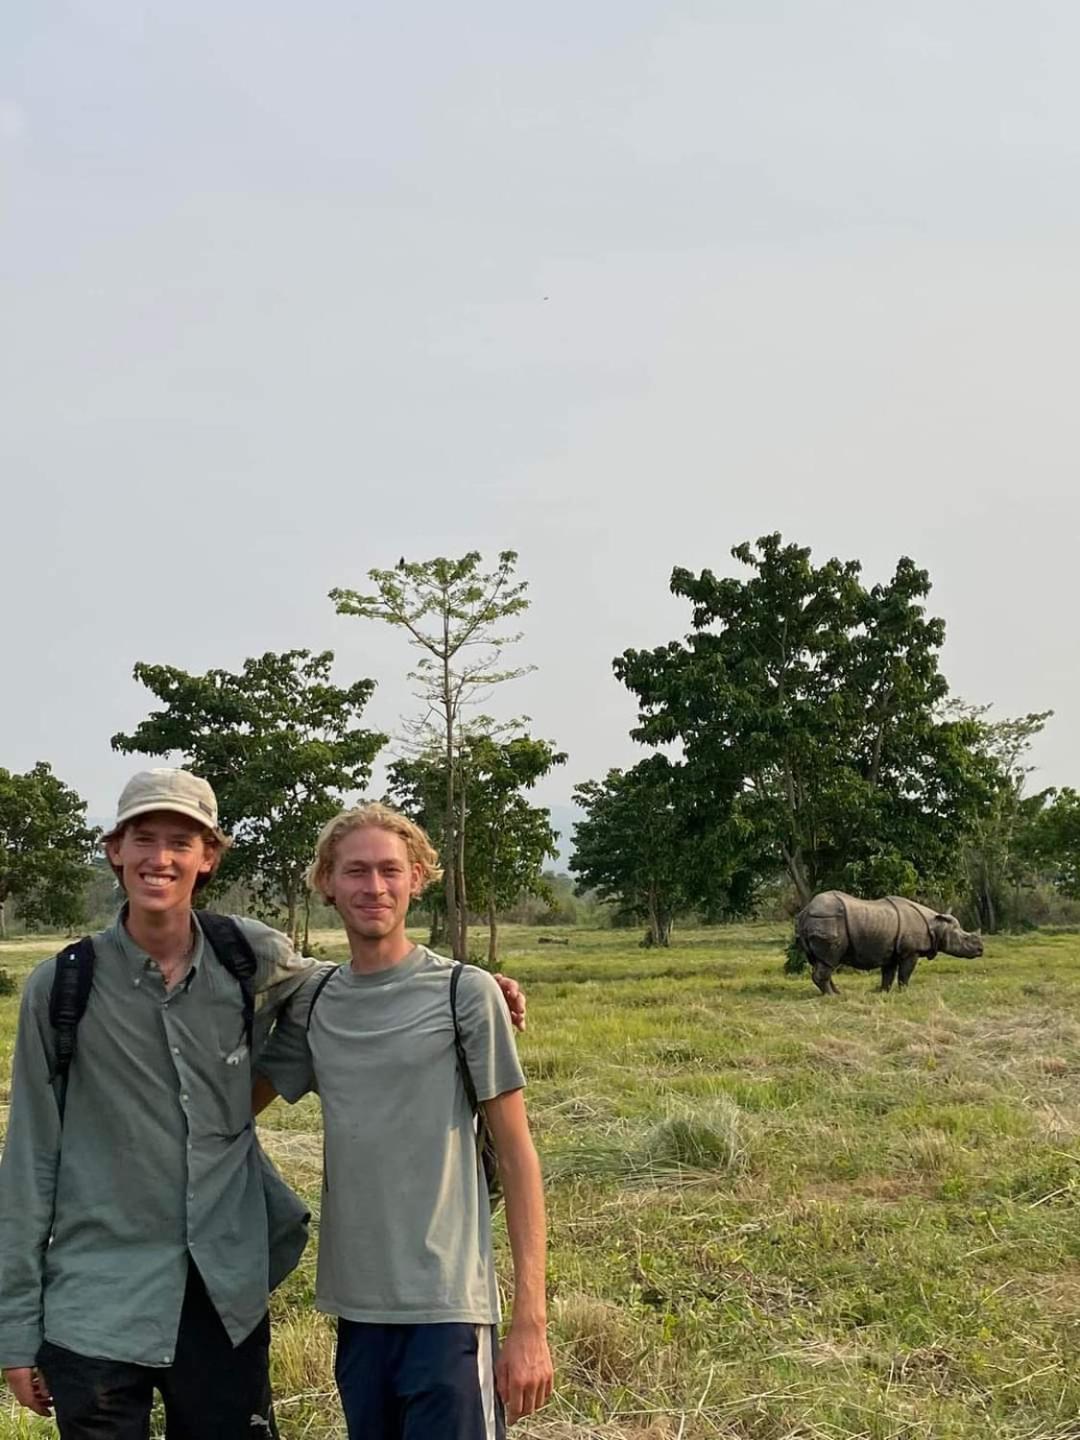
[0,534,1080,960]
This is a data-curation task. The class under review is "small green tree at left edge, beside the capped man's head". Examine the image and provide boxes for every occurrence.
[0,760,101,939]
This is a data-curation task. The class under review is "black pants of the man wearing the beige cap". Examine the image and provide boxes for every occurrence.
[37,1266,278,1440]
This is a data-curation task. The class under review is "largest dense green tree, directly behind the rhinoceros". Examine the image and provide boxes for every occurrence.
[615,534,991,903]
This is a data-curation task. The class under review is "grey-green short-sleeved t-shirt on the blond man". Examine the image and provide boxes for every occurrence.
[256,946,524,1325]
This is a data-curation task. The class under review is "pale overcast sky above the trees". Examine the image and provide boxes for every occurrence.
[0,0,1080,815]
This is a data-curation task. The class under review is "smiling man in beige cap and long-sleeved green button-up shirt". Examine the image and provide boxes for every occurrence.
[0,769,523,1440]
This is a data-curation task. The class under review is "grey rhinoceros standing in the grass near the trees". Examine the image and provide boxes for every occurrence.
[795,890,982,995]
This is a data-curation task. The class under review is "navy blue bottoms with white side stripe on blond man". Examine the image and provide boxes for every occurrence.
[334,1319,507,1440]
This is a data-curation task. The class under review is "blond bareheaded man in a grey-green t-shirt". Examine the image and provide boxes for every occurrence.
[256,805,552,1440]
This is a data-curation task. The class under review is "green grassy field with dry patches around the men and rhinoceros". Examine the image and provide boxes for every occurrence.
[0,926,1080,1440]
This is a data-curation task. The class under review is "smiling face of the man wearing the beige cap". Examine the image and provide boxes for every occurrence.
[105,811,217,913]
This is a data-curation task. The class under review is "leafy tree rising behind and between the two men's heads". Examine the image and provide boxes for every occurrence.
[112,649,386,943]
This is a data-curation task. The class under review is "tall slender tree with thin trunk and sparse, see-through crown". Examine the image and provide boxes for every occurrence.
[330,550,528,960]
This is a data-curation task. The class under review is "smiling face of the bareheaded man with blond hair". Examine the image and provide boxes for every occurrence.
[325,825,423,945]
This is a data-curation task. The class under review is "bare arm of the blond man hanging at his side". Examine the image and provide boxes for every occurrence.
[484,1090,554,1424]
